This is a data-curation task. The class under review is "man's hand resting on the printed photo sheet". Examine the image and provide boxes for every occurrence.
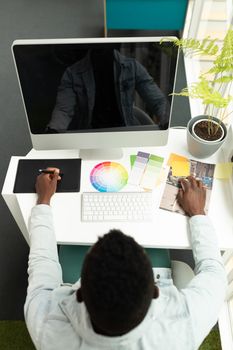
[177,176,206,216]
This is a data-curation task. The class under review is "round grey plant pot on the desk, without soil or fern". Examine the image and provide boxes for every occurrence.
[187,115,227,158]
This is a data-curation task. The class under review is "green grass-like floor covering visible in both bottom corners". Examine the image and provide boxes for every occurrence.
[0,321,221,350]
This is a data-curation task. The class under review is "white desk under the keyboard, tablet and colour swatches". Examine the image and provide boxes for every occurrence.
[2,129,233,250]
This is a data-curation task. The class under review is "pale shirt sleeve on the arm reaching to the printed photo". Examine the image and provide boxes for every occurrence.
[181,215,227,347]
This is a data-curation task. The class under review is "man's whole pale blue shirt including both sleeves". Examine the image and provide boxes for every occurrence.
[25,205,227,350]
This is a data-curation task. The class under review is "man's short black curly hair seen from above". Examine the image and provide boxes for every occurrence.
[81,230,154,335]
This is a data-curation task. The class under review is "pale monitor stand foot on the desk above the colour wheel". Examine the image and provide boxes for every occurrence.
[79,148,123,160]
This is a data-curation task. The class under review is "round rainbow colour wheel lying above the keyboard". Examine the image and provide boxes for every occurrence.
[90,162,128,192]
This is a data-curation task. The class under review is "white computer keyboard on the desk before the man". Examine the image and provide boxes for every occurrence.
[81,192,154,222]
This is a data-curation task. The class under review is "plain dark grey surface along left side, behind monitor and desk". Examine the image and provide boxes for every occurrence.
[0,0,104,320]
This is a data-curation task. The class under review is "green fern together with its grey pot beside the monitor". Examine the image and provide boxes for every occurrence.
[167,28,233,158]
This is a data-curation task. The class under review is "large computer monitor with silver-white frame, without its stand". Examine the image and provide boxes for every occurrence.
[12,37,178,157]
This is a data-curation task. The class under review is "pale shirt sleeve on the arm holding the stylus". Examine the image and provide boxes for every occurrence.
[24,204,62,344]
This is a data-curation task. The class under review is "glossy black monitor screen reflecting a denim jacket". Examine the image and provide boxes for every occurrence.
[14,42,177,134]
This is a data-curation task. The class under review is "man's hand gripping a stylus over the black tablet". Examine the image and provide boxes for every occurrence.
[36,168,61,205]
